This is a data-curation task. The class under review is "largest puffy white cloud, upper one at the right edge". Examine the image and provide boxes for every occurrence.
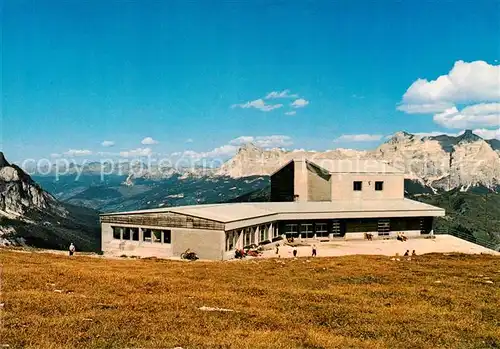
[401,61,500,112]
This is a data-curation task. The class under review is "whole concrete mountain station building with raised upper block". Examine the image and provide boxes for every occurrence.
[100,159,445,260]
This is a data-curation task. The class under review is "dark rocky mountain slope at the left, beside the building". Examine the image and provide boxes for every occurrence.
[0,152,100,251]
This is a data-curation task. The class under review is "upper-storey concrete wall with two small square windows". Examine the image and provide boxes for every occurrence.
[331,173,404,200]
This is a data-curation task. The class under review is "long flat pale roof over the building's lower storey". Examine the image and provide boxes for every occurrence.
[101,199,445,223]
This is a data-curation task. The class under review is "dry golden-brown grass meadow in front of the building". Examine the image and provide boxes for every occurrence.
[0,250,500,349]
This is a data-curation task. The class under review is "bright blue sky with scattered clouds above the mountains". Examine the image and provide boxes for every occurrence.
[0,0,500,160]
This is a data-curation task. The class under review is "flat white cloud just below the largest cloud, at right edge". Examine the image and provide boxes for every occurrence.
[434,103,500,129]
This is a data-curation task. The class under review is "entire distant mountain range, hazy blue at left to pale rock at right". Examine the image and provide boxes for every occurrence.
[31,130,500,192]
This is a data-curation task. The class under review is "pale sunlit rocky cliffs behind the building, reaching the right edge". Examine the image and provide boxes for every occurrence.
[216,131,500,192]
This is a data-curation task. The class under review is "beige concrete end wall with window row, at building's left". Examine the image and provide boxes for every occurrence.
[101,223,225,260]
